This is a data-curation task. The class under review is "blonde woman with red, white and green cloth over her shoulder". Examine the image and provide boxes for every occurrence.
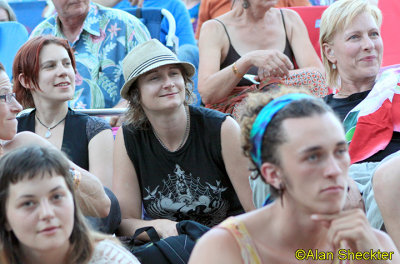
[320,0,400,247]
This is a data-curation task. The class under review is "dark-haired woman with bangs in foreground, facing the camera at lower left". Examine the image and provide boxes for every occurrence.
[0,146,139,264]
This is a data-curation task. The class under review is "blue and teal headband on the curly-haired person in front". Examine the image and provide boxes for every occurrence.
[250,93,313,168]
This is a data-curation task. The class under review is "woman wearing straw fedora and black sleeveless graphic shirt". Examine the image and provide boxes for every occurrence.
[113,40,254,237]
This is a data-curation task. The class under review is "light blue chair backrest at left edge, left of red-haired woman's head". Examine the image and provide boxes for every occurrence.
[0,21,28,77]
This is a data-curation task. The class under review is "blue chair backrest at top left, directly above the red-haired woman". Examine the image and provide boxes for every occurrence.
[9,0,46,33]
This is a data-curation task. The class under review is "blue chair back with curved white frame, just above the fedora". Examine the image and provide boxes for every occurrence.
[123,7,178,51]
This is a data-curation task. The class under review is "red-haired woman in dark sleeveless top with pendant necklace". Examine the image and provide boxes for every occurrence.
[13,35,119,232]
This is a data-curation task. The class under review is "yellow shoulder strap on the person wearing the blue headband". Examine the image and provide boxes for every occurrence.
[218,217,261,264]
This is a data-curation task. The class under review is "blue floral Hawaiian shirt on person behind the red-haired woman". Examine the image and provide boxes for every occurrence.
[31,3,150,109]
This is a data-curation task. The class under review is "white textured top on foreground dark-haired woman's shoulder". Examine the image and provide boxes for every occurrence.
[88,240,140,264]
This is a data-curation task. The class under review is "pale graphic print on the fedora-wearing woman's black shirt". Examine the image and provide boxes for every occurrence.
[143,164,229,226]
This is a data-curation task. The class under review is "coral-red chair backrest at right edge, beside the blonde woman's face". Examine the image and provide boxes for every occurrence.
[378,0,400,66]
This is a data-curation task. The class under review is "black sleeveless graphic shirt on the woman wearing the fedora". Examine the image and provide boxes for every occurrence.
[123,106,244,227]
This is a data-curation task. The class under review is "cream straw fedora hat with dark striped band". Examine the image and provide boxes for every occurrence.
[121,39,195,99]
